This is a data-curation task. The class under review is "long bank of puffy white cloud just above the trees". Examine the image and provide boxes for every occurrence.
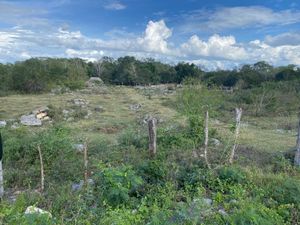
[0,20,300,69]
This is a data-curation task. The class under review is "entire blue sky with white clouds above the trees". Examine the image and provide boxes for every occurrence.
[0,0,300,70]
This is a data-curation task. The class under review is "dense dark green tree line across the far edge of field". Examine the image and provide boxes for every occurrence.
[0,56,300,93]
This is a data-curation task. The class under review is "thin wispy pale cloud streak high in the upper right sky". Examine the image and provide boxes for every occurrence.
[182,6,300,32]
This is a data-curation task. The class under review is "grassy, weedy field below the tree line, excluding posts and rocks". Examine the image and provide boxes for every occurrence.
[0,86,300,225]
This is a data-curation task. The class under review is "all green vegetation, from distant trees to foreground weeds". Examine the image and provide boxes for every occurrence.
[0,57,300,225]
